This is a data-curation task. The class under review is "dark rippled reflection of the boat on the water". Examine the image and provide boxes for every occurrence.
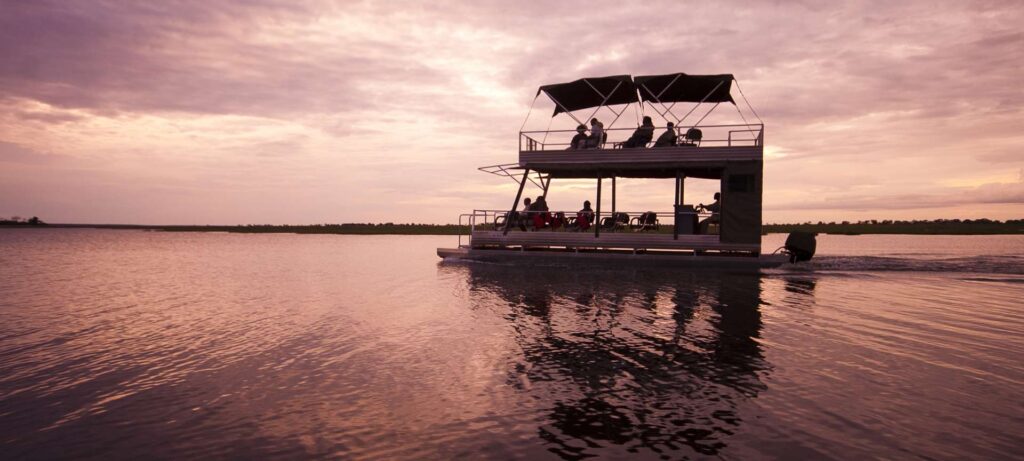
[454,264,771,459]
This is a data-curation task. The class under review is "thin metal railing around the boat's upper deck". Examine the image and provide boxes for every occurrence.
[519,124,764,152]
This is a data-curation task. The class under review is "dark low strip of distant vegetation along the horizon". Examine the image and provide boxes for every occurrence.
[0,216,1024,236]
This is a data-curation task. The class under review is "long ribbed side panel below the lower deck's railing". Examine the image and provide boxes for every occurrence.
[471,231,761,252]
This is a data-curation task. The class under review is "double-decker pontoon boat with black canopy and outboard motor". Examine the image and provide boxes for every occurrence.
[437,74,815,269]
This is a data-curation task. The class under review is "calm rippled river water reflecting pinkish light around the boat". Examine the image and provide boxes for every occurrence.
[0,229,1024,460]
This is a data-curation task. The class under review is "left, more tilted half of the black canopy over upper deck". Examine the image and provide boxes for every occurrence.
[537,75,639,117]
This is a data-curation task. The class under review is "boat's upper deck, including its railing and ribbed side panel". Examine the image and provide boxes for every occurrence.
[519,124,764,177]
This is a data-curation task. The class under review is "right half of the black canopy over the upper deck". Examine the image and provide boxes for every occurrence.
[633,74,735,103]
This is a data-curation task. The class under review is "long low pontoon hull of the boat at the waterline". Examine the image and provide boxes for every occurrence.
[437,248,790,271]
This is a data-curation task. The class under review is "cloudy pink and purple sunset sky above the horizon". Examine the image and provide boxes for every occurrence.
[0,0,1024,224]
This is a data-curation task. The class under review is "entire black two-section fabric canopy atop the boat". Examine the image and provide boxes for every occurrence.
[537,73,735,117]
